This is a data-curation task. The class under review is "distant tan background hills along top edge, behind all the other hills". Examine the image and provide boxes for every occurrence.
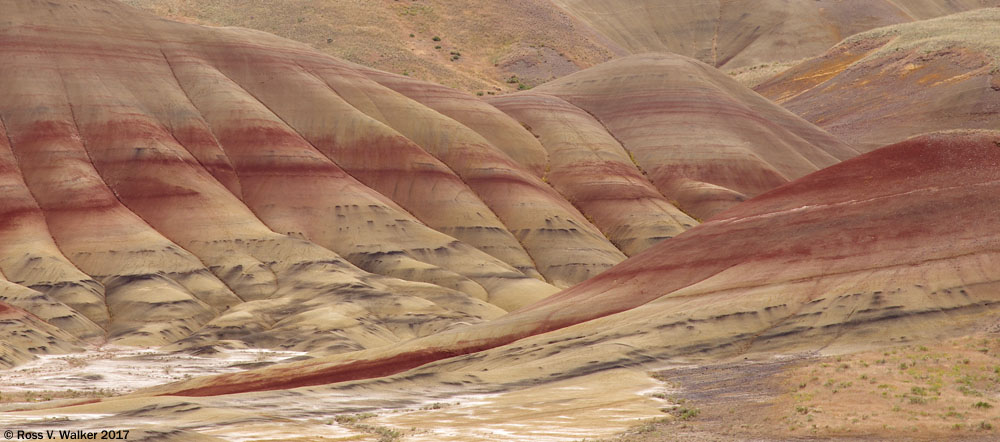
[126,0,1000,94]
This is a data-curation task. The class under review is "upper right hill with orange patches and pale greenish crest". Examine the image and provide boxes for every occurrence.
[756,8,1000,151]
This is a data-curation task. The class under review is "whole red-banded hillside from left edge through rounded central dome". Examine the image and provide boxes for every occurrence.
[0,0,854,366]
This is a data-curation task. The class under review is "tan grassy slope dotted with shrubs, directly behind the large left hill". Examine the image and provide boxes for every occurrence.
[119,0,625,93]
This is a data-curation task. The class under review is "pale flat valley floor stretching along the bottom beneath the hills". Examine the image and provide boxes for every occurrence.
[0,333,1000,442]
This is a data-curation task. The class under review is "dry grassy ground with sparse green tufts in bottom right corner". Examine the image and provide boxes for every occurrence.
[613,333,1000,442]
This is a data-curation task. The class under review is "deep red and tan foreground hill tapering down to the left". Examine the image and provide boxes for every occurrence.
[153,132,1000,396]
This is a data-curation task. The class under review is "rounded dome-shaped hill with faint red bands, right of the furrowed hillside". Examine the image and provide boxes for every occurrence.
[520,54,856,219]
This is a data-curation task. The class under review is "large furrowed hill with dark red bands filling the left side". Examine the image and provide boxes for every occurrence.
[0,1,600,365]
